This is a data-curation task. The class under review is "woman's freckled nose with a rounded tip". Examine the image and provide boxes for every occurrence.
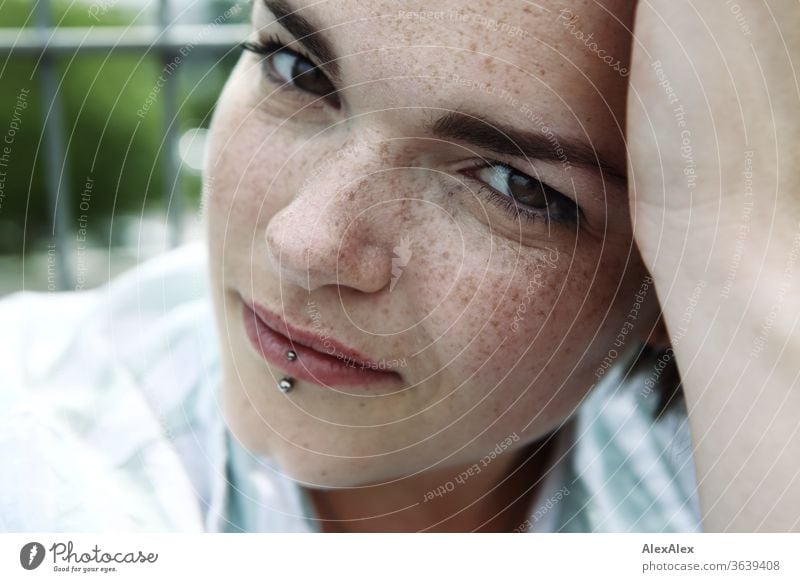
[265,148,399,293]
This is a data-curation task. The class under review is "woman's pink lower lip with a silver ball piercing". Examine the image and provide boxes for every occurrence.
[242,303,401,388]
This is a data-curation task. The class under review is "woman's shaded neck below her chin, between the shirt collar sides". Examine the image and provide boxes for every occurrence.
[308,438,555,532]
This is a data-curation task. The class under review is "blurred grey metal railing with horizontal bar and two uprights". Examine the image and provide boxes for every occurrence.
[0,0,249,289]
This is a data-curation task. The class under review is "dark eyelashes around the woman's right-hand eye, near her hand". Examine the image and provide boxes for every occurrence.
[462,160,583,226]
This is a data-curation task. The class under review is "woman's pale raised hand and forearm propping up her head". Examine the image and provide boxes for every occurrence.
[626,0,800,531]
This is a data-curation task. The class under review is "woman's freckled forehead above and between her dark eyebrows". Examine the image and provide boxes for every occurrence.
[254,0,634,157]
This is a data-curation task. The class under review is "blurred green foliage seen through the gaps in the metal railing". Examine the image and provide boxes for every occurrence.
[0,0,236,254]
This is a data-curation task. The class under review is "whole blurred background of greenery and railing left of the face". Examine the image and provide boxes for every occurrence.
[0,0,250,295]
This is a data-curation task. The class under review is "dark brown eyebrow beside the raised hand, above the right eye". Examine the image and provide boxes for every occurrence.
[431,111,628,184]
